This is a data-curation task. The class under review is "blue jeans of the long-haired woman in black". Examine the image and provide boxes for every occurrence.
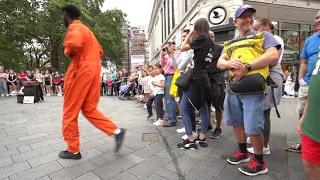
[180,86,209,136]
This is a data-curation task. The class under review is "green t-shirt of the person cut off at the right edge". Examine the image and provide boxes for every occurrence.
[301,47,320,143]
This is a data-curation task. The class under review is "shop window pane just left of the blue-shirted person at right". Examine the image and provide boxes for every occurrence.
[281,30,300,61]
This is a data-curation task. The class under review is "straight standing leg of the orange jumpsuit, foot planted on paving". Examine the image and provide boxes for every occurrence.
[62,72,93,153]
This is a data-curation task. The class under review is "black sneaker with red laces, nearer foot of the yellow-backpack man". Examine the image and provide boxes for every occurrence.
[239,158,268,176]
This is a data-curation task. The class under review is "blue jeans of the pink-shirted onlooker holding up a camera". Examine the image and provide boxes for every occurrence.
[164,75,177,123]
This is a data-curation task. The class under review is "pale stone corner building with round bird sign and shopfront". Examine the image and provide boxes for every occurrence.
[148,0,320,74]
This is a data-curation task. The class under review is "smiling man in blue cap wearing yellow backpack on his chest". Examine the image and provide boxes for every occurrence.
[217,5,281,176]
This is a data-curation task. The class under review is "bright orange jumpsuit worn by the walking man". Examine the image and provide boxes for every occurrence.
[62,20,118,153]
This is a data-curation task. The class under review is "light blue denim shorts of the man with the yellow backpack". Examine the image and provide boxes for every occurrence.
[223,92,265,135]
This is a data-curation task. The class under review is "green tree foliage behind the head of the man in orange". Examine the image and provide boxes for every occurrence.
[0,0,125,71]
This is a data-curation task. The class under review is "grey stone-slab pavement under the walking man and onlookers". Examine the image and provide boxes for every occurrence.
[0,97,305,180]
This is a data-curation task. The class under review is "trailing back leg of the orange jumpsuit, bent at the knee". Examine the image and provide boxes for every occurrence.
[82,76,118,135]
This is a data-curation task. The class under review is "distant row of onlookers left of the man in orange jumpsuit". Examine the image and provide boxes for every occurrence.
[0,69,64,97]
